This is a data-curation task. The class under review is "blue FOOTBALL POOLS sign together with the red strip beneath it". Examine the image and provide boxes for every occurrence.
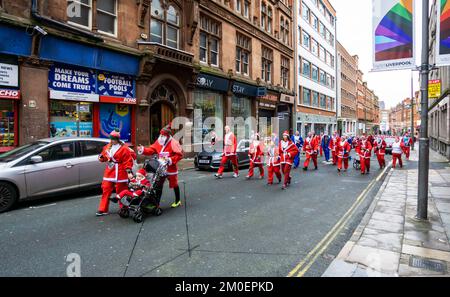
[97,72,137,104]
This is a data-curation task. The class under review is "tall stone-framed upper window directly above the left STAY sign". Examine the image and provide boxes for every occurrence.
[199,15,221,67]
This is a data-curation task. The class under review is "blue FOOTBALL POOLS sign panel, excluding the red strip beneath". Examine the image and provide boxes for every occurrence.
[97,71,135,98]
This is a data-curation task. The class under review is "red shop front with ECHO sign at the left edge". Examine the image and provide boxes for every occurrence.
[0,61,20,153]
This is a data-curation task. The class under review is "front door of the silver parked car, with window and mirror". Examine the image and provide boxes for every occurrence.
[25,141,79,196]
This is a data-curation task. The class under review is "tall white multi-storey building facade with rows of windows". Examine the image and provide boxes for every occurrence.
[296,0,337,135]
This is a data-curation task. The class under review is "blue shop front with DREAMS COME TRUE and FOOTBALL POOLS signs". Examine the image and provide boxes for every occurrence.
[49,64,136,143]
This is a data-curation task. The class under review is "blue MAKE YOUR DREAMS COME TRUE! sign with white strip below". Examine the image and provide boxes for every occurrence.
[48,65,99,102]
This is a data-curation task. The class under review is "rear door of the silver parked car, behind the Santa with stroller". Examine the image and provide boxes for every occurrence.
[77,140,107,188]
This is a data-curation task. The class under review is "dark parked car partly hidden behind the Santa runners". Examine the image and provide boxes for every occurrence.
[194,139,250,170]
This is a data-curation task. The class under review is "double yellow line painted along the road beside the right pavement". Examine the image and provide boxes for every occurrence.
[288,166,390,277]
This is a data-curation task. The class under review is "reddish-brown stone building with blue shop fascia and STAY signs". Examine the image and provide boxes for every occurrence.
[0,0,297,155]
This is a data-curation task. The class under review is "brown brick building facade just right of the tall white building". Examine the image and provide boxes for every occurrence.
[337,42,358,136]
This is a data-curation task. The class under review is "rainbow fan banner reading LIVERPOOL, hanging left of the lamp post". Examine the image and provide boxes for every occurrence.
[372,0,415,71]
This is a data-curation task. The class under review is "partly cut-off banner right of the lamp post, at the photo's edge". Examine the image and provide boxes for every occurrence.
[436,0,450,66]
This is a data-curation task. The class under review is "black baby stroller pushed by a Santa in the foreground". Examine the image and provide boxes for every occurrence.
[119,158,167,223]
